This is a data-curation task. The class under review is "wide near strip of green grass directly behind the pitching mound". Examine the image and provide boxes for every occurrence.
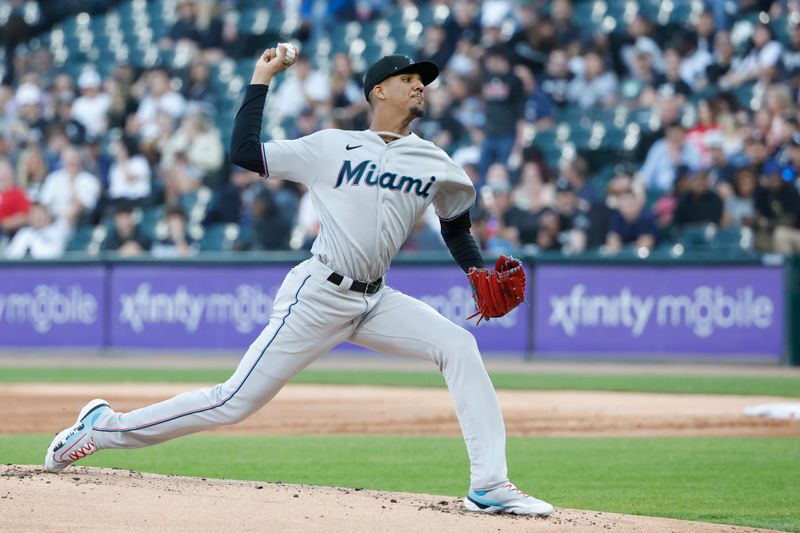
[0,435,800,531]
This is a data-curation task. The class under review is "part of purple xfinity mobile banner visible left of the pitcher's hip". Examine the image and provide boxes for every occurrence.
[111,265,290,353]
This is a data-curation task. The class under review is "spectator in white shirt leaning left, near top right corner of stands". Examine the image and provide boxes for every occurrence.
[719,23,783,88]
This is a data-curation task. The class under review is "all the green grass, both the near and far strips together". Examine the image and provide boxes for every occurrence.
[6,368,800,532]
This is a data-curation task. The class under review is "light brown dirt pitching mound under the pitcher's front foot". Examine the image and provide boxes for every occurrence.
[0,465,766,533]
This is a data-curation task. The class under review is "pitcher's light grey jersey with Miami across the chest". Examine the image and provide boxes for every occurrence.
[261,129,475,281]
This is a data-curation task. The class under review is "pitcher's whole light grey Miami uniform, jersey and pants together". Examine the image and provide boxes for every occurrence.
[87,130,508,491]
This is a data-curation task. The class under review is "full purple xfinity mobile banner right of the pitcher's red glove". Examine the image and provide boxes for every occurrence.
[534,265,784,360]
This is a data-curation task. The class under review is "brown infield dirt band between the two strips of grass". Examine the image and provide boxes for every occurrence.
[0,383,800,436]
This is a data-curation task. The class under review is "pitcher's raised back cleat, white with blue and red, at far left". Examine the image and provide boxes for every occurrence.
[44,400,111,472]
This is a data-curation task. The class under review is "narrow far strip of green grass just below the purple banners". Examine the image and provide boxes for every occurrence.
[0,368,800,397]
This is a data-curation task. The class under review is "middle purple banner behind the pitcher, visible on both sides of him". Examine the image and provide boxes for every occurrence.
[110,265,529,352]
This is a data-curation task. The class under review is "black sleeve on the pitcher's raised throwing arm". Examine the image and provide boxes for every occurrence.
[231,85,269,176]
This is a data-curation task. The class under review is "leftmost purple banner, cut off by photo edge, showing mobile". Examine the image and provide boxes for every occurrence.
[0,265,106,348]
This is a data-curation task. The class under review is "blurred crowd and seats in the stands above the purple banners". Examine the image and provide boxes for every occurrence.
[0,0,800,258]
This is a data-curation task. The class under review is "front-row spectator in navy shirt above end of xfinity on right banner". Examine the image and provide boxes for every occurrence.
[606,189,658,253]
